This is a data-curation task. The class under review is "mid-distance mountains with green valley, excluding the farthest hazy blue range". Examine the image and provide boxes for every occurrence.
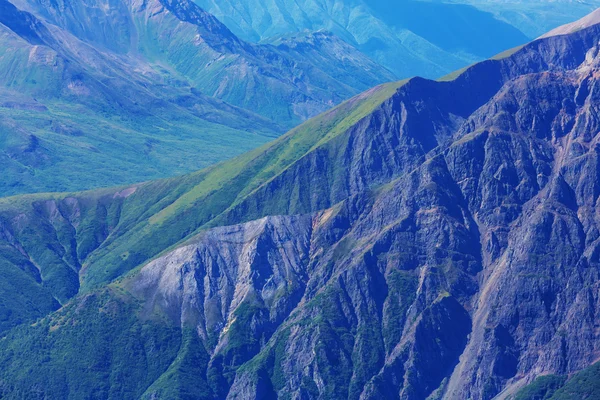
[0,0,393,196]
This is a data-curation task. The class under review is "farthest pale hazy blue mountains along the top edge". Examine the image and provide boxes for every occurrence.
[195,0,528,78]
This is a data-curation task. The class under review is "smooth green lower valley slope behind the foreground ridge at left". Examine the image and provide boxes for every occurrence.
[0,92,278,195]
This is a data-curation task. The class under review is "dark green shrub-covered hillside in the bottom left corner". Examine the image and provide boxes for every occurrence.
[0,291,185,399]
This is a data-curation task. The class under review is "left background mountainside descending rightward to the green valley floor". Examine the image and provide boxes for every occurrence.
[0,1,281,195]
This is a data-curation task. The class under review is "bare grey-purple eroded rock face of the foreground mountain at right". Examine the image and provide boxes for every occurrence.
[124,27,600,399]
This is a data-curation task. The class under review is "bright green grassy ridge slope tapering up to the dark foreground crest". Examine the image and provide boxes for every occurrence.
[0,83,408,334]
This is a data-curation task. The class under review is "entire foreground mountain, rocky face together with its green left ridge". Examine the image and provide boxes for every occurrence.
[0,13,600,399]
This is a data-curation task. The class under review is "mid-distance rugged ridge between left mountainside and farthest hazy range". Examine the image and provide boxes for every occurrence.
[5,0,391,125]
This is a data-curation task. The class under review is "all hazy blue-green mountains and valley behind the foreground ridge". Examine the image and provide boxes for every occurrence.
[0,0,592,195]
